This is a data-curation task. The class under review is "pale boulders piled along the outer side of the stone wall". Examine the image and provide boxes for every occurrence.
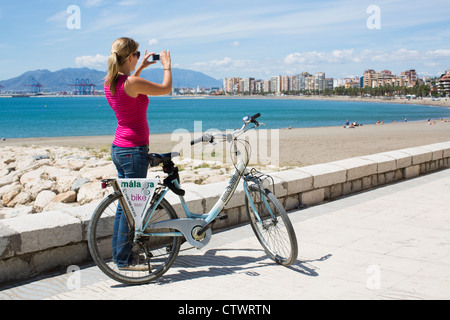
[0,146,286,219]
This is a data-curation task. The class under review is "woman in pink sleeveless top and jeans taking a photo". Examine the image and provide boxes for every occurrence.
[105,38,172,271]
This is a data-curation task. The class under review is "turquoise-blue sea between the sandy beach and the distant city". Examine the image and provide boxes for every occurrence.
[0,96,450,139]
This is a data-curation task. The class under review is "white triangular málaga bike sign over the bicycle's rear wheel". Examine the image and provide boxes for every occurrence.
[117,179,159,228]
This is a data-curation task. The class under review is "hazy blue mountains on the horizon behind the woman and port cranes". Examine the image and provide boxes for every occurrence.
[0,68,222,92]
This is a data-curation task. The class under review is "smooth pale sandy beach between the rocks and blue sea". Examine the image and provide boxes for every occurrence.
[0,119,450,166]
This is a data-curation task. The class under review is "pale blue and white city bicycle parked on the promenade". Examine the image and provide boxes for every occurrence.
[88,113,298,285]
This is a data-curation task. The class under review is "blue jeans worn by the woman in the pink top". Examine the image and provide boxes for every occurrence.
[111,145,149,267]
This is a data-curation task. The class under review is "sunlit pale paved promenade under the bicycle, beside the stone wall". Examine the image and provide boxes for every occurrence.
[0,169,450,300]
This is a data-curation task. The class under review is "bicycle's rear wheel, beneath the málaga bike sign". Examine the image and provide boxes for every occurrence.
[88,192,181,285]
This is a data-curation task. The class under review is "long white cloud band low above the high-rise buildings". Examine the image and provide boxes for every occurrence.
[185,48,450,79]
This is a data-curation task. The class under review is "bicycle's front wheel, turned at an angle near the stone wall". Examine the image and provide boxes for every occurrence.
[245,185,298,266]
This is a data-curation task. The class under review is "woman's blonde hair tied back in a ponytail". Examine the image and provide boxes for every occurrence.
[105,38,139,95]
